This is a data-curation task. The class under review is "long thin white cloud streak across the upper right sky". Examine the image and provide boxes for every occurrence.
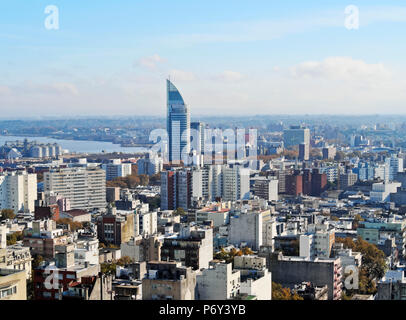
[157,5,406,47]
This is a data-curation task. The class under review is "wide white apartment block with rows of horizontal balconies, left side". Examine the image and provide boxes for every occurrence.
[44,168,106,210]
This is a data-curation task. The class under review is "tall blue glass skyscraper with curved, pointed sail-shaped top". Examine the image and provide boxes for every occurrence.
[166,80,190,163]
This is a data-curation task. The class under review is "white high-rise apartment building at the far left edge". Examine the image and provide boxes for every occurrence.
[0,171,37,212]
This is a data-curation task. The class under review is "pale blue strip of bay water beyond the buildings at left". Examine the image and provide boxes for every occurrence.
[0,135,147,154]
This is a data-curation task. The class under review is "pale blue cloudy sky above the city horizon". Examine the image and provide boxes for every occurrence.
[0,0,406,118]
